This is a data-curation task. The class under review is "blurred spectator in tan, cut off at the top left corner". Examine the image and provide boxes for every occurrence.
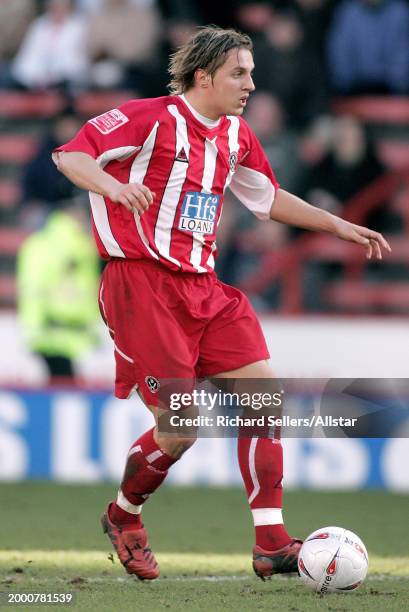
[0,0,36,86]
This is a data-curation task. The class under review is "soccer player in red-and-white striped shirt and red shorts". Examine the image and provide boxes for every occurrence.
[54,26,390,579]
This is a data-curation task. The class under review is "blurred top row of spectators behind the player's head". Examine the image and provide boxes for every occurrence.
[0,0,409,97]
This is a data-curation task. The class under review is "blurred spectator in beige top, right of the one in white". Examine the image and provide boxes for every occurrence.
[88,0,161,94]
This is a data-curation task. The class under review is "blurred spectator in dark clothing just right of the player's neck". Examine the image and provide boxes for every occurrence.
[245,91,302,193]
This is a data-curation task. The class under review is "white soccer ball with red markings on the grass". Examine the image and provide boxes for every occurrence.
[298,527,368,594]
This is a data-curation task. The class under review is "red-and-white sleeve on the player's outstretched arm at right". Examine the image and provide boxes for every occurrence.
[230,124,279,220]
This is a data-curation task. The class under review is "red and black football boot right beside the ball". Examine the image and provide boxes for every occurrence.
[253,538,302,580]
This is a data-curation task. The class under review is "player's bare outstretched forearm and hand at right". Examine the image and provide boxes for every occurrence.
[270,189,391,259]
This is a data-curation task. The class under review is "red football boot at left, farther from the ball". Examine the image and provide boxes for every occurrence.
[101,504,159,580]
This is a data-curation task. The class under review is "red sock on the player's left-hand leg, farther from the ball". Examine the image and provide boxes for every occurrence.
[110,428,177,528]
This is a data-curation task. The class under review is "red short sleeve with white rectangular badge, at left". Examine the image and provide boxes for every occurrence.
[55,101,149,159]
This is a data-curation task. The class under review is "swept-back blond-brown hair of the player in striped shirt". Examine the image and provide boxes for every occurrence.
[168,25,253,94]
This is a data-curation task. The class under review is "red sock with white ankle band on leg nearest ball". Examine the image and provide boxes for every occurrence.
[237,438,291,551]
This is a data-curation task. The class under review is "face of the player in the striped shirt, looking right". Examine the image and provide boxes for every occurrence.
[208,49,255,116]
